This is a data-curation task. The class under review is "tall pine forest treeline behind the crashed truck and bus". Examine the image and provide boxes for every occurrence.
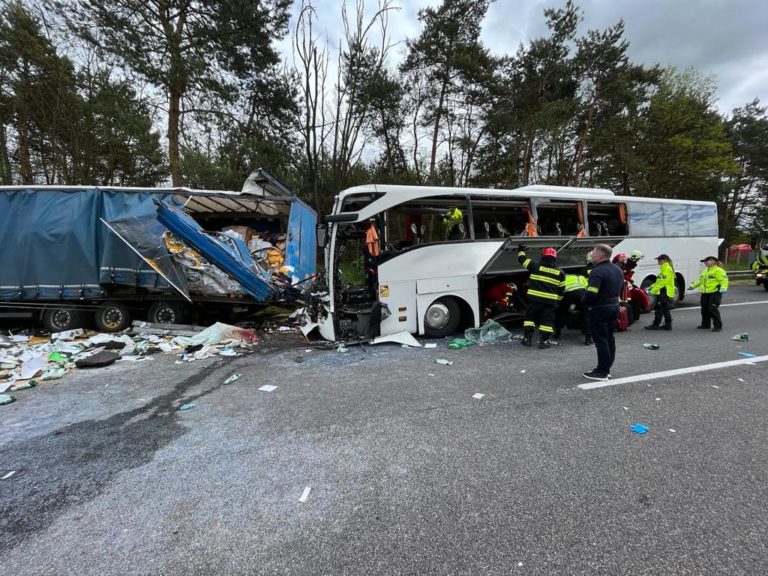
[0,0,768,245]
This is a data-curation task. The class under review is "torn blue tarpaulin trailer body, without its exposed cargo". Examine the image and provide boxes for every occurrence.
[0,170,317,330]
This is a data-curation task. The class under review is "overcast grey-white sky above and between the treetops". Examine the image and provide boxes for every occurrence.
[282,0,768,115]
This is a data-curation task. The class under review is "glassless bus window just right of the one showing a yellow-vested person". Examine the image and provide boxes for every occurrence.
[472,196,535,240]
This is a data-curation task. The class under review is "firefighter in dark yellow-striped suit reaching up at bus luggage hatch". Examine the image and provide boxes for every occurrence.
[517,244,565,348]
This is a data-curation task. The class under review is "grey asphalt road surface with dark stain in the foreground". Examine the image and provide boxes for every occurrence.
[0,286,768,576]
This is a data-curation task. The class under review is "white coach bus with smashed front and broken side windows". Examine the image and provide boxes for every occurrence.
[304,184,721,341]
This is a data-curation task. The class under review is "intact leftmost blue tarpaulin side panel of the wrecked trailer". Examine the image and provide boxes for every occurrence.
[0,189,102,300]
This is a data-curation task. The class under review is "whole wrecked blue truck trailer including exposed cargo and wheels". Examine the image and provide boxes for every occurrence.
[0,169,317,332]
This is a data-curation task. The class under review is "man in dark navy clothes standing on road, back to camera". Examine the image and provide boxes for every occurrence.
[582,244,624,380]
